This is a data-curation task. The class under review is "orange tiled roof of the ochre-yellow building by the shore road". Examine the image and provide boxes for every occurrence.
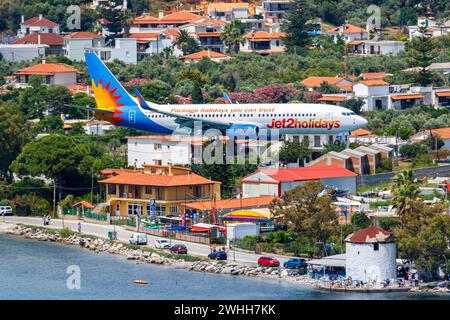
[99,170,221,187]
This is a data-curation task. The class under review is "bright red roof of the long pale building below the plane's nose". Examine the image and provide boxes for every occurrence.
[242,166,356,182]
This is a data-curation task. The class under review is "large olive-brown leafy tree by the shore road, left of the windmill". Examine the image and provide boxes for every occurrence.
[270,181,338,256]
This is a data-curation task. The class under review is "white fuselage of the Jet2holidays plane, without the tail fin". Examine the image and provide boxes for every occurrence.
[141,103,367,134]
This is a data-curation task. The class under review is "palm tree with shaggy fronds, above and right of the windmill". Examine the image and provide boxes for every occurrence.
[391,170,420,222]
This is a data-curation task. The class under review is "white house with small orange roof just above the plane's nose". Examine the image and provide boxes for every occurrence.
[353,80,391,111]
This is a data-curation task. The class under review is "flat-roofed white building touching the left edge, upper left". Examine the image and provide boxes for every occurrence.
[0,44,48,62]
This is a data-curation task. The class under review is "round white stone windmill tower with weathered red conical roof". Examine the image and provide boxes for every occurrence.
[345,226,397,284]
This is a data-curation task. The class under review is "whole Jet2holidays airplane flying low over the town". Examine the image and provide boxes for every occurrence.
[73,52,367,137]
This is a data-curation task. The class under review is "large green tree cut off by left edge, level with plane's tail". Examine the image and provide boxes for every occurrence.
[0,101,34,181]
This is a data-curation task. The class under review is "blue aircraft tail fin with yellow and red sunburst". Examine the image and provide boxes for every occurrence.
[84,52,136,111]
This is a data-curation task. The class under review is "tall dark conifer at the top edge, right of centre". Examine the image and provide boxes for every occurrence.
[283,0,314,53]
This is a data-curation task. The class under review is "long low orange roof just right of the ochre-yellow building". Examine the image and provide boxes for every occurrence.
[186,196,275,210]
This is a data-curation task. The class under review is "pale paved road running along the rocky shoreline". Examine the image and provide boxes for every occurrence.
[0,216,289,264]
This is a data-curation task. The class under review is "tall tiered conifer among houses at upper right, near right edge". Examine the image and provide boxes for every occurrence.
[407,26,436,87]
